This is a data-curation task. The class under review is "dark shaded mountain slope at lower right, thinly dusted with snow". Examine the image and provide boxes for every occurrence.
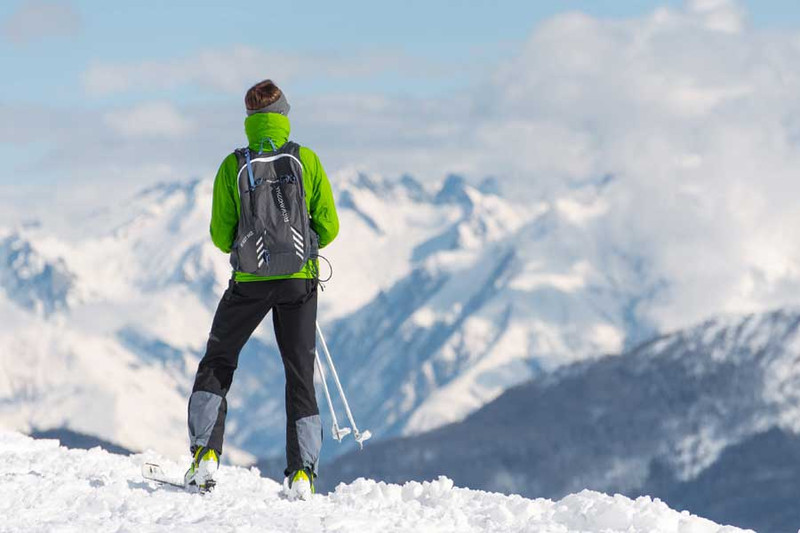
[323,310,800,532]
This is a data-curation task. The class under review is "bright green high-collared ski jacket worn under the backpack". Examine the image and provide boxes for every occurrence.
[211,113,339,281]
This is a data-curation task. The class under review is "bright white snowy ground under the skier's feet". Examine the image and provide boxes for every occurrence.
[0,432,742,533]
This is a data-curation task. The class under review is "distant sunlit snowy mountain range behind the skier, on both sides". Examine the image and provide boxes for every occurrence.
[0,171,658,461]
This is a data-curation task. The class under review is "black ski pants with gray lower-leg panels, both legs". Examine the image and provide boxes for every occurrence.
[189,279,322,475]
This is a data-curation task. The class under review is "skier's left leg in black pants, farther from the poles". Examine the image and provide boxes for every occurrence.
[189,282,272,453]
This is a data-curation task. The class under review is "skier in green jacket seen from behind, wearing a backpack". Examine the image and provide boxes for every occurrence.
[184,80,339,499]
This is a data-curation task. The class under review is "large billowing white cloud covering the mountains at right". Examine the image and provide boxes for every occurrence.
[485,0,800,327]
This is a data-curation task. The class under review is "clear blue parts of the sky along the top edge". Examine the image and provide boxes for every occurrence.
[0,0,800,106]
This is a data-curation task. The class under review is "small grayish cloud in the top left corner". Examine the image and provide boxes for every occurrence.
[2,0,81,44]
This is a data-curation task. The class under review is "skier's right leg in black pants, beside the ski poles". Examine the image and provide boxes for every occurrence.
[272,279,322,476]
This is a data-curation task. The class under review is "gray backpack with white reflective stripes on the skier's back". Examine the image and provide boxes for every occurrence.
[231,141,319,276]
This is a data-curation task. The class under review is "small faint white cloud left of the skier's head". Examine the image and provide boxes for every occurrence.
[104,102,191,138]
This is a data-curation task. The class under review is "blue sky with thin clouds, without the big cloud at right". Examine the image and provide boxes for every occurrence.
[0,0,800,193]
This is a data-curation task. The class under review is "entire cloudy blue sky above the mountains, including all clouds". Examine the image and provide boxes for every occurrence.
[0,0,800,327]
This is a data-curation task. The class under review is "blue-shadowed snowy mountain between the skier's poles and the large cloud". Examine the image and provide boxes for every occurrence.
[322,171,663,436]
